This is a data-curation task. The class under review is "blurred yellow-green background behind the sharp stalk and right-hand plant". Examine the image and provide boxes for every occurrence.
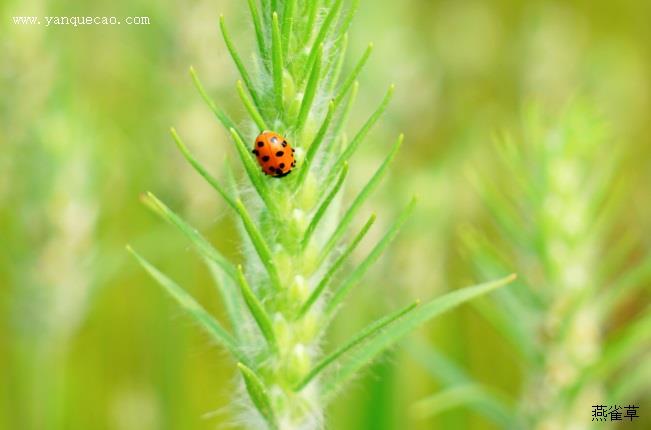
[0,0,651,430]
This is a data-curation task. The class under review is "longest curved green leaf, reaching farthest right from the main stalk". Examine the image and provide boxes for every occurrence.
[323,275,515,400]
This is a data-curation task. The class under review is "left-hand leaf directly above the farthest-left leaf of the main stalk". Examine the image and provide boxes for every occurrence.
[142,192,237,280]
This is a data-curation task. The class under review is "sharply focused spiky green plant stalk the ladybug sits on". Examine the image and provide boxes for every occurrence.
[127,0,511,429]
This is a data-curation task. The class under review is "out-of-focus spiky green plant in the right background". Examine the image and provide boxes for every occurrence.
[414,101,651,430]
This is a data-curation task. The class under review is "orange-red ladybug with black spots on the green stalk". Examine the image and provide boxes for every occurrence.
[252,131,296,178]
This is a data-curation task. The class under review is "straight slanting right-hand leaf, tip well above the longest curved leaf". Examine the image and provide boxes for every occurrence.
[325,198,416,315]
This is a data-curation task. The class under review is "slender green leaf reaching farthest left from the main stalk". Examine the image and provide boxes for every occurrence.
[127,246,247,362]
